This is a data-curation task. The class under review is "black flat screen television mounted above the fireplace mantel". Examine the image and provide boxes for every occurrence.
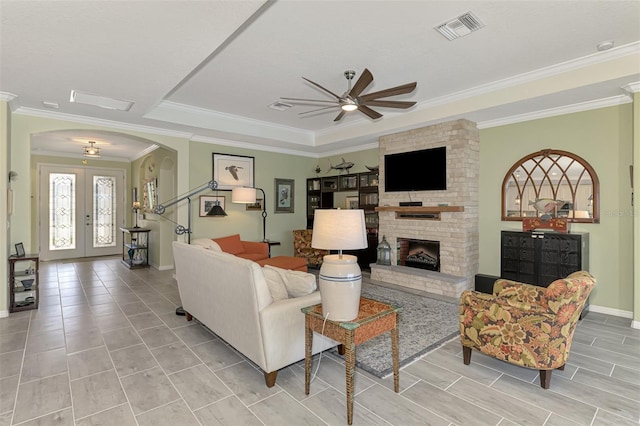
[384,146,447,192]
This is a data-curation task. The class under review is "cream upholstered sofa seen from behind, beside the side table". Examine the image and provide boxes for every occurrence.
[173,242,338,387]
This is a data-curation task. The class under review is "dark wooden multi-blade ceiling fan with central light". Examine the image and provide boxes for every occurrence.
[280,68,417,121]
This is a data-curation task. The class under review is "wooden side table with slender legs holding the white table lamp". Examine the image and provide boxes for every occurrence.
[301,297,402,424]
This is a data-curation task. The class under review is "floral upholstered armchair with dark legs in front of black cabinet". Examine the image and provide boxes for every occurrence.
[460,271,596,389]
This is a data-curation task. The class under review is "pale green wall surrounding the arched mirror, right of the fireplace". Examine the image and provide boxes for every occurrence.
[480,104,633,313]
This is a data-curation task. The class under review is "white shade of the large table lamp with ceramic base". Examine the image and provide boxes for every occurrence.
[311,209,367,250]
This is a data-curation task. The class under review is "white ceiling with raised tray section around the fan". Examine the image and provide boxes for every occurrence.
[0,0,640,158]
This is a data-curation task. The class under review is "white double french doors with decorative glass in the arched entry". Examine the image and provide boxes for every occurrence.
[38,165,125,260]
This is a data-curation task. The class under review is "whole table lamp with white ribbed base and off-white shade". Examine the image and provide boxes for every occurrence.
[311,209,367,321]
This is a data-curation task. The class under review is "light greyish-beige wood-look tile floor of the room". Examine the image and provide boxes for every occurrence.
[0,258,640,426]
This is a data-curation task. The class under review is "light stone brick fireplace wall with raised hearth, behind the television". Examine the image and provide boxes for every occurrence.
[371,119,480,297]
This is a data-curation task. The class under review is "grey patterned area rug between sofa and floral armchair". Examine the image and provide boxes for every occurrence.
[332,276,459,378]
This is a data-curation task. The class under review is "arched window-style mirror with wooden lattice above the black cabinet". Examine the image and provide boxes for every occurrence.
[502,149,600,223]
